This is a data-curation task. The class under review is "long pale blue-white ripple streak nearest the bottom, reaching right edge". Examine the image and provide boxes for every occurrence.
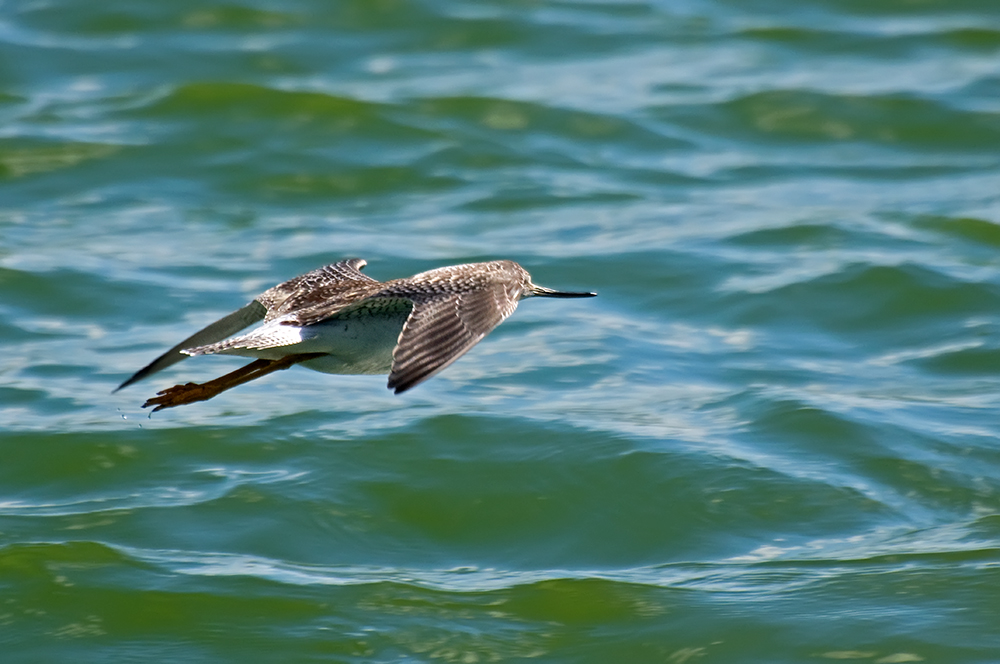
[80,526,1000,595]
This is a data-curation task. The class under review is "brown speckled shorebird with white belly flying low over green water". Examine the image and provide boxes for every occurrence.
[121,258,597,412]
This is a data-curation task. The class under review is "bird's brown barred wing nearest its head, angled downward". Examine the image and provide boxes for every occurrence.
[389,284,517,394]
